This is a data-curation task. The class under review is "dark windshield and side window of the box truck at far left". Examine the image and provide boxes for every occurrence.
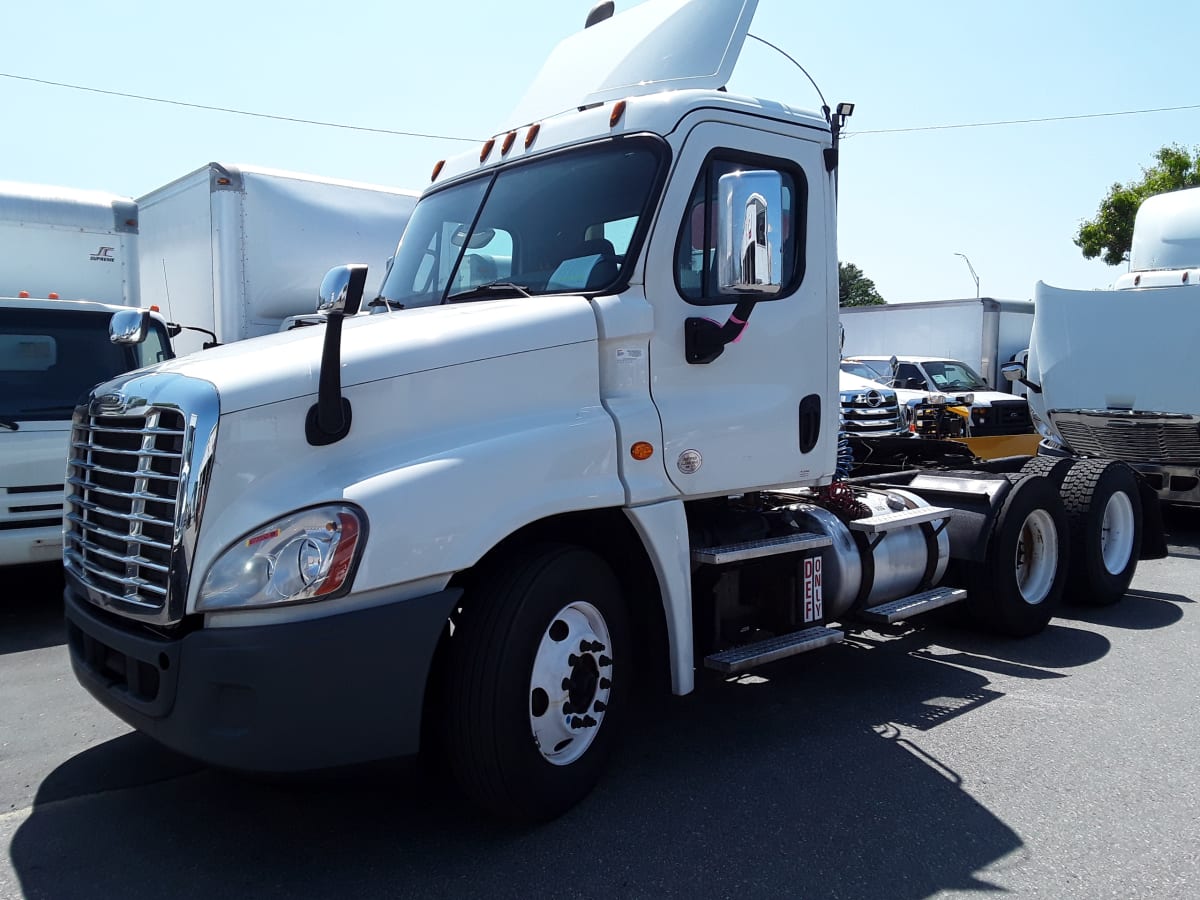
[0,307,167,421]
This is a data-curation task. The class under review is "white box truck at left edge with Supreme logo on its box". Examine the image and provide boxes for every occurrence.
[0,181,170,565]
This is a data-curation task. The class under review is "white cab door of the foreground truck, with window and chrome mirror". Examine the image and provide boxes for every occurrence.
[646,120,838,497]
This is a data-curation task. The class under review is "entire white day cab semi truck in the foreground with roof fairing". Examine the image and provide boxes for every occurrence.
[65,0,1152,820]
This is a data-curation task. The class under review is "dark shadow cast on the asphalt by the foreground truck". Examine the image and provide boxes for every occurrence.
[10,625,1109,900]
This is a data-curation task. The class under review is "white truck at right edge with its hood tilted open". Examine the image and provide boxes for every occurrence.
[1006,187,1200,506]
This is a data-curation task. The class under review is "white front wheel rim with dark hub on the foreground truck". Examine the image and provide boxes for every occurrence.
[529,601,612,766]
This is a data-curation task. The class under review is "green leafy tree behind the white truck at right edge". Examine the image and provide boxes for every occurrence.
[1075,144,1200,265]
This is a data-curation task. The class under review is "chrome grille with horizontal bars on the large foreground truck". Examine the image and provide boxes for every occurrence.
[62,407,187,612]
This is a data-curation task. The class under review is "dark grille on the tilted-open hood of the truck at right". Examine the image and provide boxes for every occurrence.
[1050,410,1200,466]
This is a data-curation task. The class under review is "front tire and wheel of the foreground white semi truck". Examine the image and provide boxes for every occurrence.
[443,544,632,823]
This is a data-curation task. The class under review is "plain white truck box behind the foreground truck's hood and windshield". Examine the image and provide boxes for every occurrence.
[138,162,416,354]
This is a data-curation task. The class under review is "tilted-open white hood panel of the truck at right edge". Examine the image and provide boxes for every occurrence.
[1028,282,1200,414]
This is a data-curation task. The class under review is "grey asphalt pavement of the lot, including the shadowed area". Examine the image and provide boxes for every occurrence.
[0,514,1200,900]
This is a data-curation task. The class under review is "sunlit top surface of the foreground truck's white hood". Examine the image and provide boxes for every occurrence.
[137,296,596,413]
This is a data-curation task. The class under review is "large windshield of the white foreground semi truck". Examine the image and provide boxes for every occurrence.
[382,138,664,308]
